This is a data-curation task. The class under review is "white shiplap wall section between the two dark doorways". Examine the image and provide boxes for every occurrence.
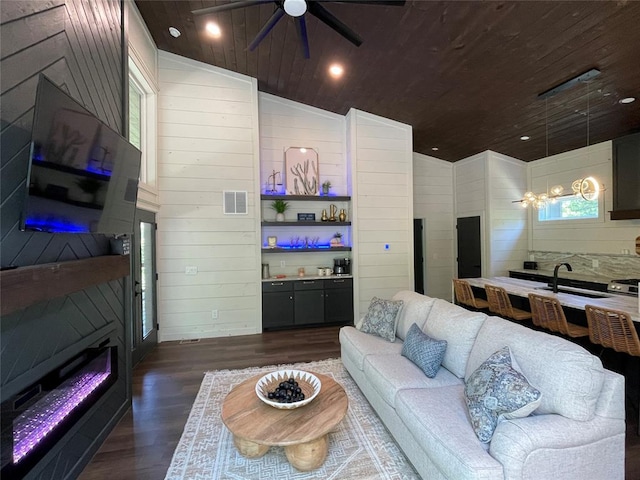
[413,153,455,300]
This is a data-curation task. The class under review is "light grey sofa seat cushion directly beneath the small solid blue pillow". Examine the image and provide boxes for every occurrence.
[364,354,462,407]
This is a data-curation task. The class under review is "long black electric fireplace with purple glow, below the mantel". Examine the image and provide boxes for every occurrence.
[1,340,118,478]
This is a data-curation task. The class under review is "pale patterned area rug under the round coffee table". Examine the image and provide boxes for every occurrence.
[165,359,420,480]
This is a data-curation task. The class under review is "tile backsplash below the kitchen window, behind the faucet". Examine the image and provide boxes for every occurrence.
[529,250,640,279]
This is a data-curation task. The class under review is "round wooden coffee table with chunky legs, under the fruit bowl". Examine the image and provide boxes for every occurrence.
[222,372,349,471]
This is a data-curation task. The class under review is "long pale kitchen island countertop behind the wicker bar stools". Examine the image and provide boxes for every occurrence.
[464,277,640,323]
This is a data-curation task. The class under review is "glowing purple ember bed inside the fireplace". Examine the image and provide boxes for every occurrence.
[13,369,111,463]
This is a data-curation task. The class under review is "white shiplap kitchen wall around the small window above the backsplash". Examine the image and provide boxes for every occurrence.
[529,141,640,255]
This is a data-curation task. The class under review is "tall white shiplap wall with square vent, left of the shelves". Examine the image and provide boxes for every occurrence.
[157,52,261,341]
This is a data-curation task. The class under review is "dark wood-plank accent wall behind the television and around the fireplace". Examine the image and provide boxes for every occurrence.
[0,0,131,479]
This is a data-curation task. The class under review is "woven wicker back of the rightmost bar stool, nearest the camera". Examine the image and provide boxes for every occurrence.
[584,305,640,357]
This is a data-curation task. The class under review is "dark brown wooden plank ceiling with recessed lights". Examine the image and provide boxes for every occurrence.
[136,0,640,162]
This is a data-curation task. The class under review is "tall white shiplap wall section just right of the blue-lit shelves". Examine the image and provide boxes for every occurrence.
[347,109,414,318]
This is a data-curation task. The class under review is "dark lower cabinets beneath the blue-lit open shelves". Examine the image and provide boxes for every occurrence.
[262,278,353,330]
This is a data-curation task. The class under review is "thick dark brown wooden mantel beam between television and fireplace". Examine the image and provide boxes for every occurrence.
[0,255,130,315]
